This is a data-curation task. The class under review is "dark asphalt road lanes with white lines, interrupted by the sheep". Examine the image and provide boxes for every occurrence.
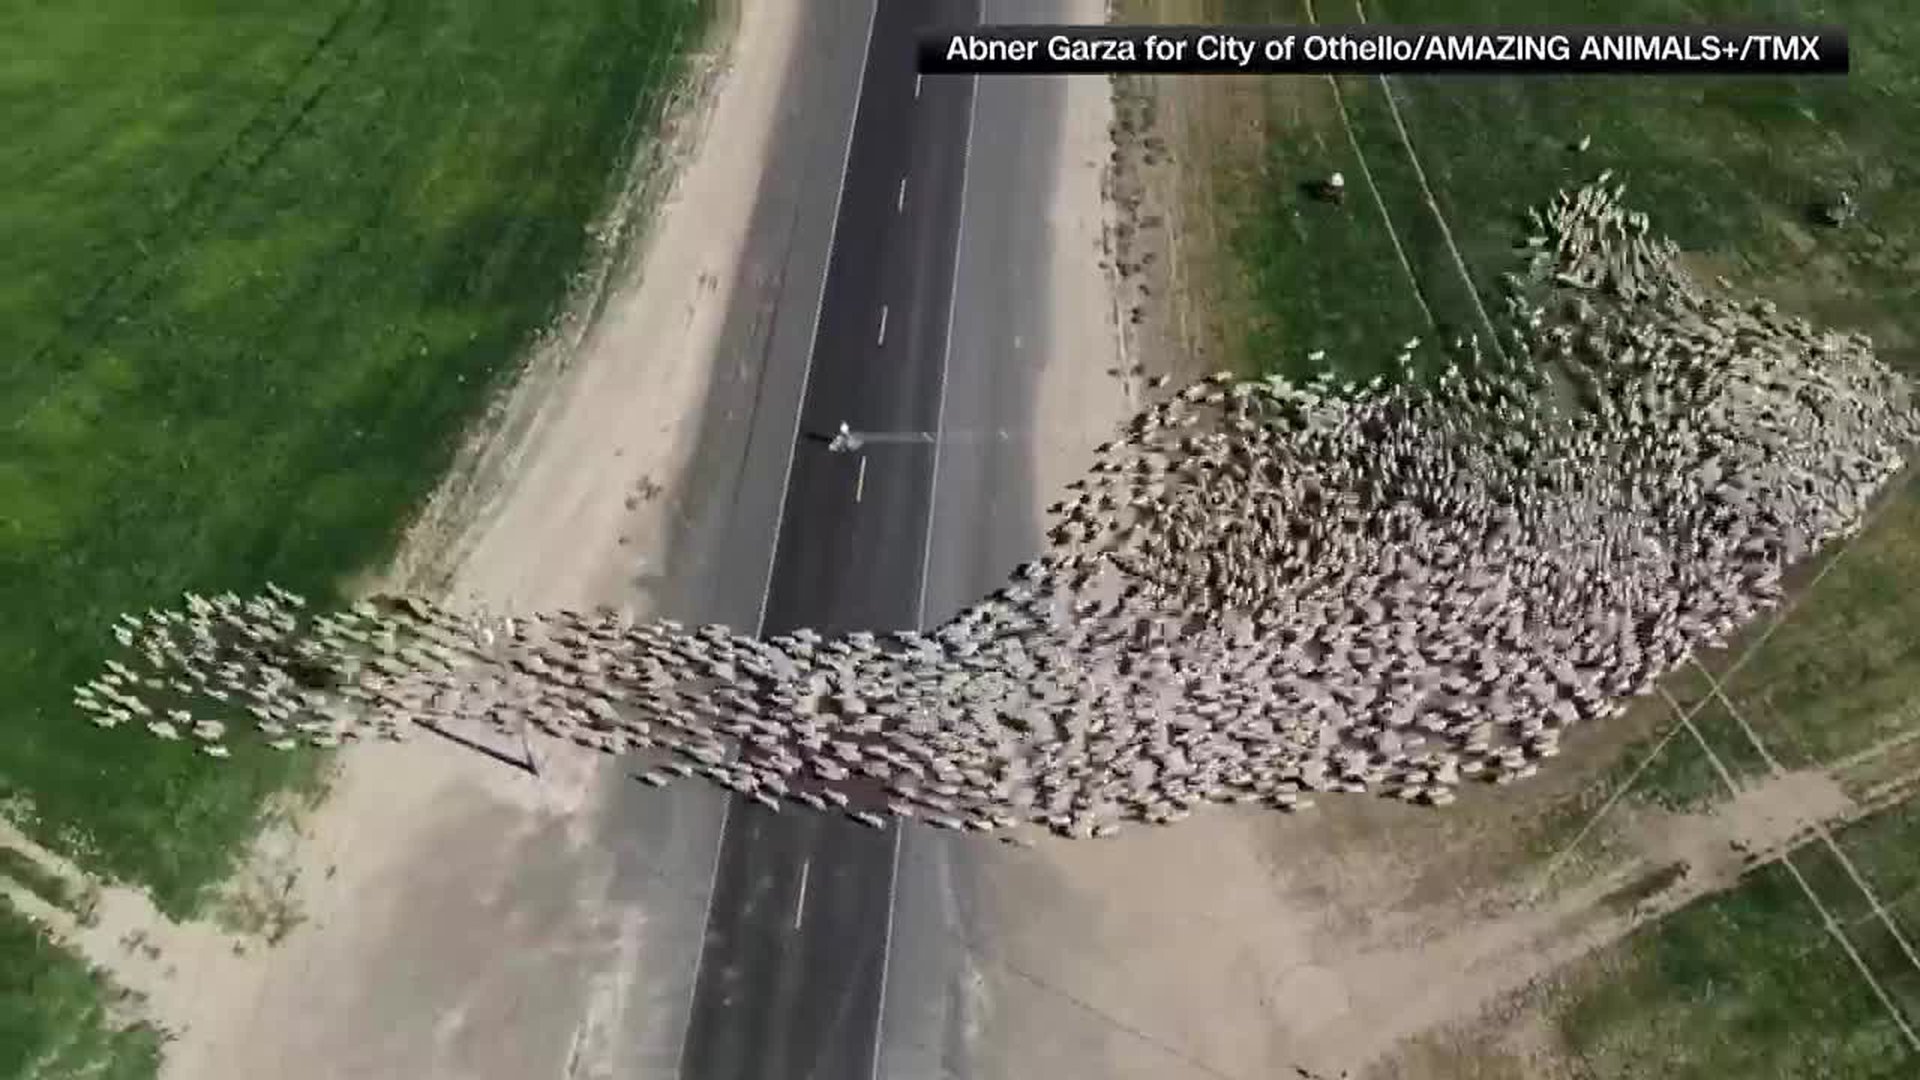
[680,0,979,1080]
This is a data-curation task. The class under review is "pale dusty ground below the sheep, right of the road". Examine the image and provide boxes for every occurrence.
[981,707,1889,1078]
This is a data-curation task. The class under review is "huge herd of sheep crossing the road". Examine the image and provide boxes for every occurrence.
[75,175,1920,836]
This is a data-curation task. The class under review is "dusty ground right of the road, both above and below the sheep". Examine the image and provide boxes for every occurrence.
[973,14,1905,1080]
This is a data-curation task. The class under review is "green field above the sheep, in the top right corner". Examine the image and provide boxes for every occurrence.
[1190,0,1920,382]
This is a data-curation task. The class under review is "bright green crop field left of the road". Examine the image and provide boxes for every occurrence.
[0,0,714,1076]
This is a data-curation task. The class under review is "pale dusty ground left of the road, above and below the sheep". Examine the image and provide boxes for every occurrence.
[0,4,799,1080]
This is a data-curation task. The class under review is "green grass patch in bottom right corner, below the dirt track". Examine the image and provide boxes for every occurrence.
[1532,780,1920,1080]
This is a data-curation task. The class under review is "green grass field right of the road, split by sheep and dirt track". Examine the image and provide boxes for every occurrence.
[1158,0,1920,1080]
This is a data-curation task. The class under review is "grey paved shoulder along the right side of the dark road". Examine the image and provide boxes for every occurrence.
[876,0,1104,1080]
